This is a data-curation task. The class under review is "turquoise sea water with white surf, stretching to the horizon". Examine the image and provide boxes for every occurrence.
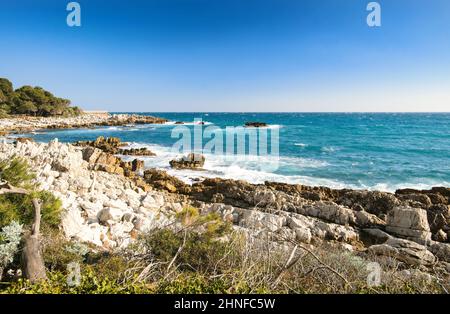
[22,113,450,191]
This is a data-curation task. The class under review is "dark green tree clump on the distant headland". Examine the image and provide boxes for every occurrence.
[0,78,81,118]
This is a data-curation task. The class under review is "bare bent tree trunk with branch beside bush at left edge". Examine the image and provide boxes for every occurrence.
[0,182,47,283]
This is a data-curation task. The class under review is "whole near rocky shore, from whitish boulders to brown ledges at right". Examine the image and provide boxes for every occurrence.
[0,140,450,275]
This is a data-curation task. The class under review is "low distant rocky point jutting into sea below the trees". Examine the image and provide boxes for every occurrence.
[0,113,168,135]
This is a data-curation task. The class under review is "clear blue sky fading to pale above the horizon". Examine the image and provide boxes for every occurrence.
[0,0,450,111]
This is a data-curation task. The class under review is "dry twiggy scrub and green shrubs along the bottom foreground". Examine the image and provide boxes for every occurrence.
[0,207,445,294]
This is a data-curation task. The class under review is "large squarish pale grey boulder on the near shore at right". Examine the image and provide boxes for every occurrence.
[386,207,431,243]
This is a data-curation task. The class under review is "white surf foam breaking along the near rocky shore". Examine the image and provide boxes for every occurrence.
[123,143,450,192]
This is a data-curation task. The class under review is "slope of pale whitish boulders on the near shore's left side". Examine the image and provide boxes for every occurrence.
[0,141,172,249]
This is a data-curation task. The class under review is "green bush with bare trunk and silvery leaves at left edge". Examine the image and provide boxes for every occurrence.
[0,158,61,283]
